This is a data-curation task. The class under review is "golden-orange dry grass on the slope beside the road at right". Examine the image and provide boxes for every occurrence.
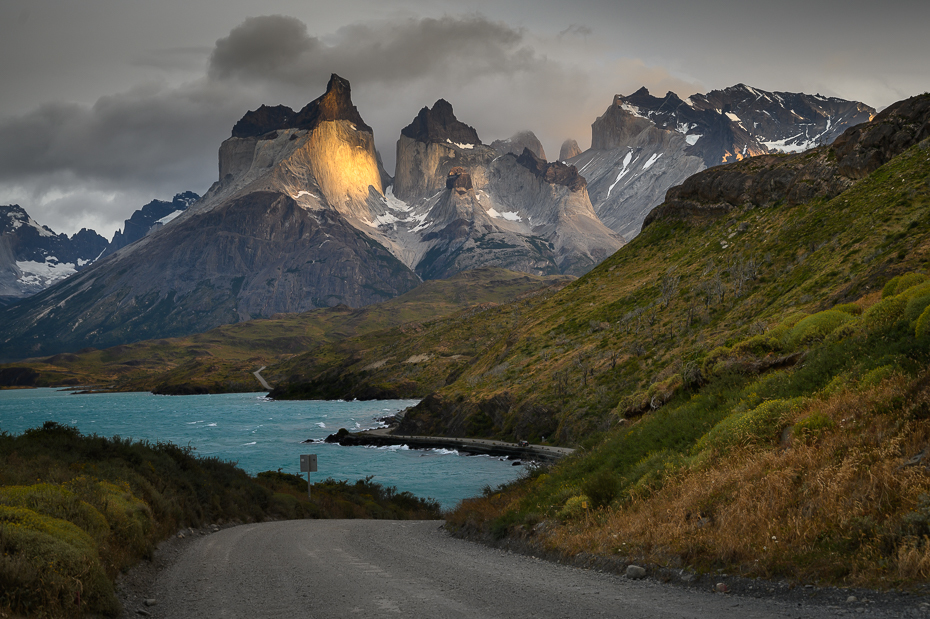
[546,378,930,585]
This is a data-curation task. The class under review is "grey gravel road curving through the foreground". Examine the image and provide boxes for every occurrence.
[124,520,928,619]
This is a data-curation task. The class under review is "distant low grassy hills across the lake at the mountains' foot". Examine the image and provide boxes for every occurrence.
[0,268,570,393]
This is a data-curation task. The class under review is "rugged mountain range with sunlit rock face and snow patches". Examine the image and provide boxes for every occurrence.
[0,75,872,358]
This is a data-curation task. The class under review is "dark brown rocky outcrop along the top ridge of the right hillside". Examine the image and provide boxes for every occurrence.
[643,95,930,227]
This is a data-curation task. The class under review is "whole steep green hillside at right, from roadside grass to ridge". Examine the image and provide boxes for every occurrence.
[434,95,930,588]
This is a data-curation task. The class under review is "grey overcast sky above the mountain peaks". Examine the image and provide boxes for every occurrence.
[0,0,930,238]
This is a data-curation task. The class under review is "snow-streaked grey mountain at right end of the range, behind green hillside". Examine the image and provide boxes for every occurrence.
[567,84,875,239]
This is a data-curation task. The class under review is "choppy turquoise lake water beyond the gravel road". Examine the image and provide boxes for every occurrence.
[0,389,522,507]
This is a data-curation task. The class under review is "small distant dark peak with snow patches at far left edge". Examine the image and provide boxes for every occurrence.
[0,205,107,305]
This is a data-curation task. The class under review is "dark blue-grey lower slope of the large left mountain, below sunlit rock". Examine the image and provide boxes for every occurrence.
[0,192,419,359]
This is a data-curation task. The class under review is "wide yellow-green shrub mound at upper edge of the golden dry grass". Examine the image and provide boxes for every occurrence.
[695,398,804,452]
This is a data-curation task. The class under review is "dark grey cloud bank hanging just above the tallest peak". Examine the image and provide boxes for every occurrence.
[209,15,546,84]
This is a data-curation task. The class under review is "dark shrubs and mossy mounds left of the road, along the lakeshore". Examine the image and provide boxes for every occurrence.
[0,422,441,617]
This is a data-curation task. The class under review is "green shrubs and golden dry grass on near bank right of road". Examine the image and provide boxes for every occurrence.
[449,274,930,587]
